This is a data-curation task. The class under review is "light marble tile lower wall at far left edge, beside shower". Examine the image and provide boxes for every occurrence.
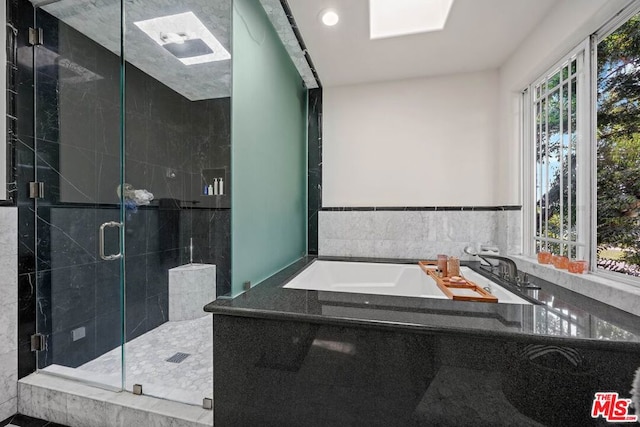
[0,207,18,419]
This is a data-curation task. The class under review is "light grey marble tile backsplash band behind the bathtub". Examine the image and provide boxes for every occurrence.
[318,210,521,259]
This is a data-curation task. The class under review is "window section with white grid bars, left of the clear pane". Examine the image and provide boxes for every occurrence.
[525,44,589,258]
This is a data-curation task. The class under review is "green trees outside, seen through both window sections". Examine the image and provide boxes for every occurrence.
[536,14,640,265]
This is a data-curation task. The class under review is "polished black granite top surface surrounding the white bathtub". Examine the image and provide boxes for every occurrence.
[205,257,640,351]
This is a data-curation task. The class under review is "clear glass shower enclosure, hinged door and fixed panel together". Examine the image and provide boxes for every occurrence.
[31,0,232,404]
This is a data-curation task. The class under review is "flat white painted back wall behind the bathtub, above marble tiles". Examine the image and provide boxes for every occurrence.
[322,71,499,207]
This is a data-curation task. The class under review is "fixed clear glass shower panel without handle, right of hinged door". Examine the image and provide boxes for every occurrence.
[119,0,233,406]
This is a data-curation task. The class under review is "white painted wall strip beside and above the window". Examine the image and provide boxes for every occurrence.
[496,0,630,205]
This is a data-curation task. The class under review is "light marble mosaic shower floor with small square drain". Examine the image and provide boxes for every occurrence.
[45,314,213,405]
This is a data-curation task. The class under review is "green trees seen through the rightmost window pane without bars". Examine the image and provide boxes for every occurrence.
[597,15,640,264]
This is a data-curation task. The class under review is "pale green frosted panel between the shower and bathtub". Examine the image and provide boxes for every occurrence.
[231,0,307,295]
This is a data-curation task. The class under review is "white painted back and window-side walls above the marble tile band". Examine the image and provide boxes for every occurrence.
[323,0,632,207]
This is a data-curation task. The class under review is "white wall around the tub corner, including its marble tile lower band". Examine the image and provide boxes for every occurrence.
[319,0,630,258]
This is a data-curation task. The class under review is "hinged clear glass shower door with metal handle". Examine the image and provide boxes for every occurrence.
[32,0,125,389]
